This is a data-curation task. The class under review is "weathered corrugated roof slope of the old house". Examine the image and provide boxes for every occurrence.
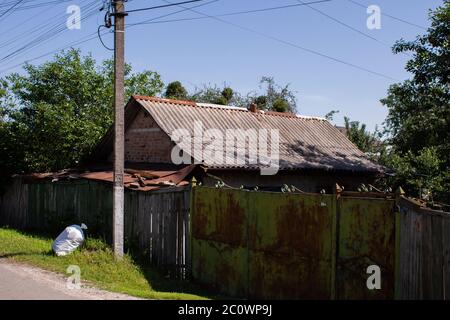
[128,96,384,172]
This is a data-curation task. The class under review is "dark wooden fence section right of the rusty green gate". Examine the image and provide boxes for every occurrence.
[396,197,450,300]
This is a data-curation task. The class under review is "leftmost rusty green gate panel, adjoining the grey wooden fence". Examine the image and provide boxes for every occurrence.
[191,187,248,297]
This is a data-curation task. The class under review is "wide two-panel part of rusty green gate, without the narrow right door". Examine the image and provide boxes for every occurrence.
[191,187,335,299]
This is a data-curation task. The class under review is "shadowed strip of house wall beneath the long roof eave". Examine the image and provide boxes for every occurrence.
[202,170,375,193]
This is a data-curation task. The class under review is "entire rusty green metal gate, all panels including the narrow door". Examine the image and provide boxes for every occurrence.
[191,187,395,299]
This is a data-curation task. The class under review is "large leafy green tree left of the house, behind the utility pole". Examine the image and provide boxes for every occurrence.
[0,49,163,176]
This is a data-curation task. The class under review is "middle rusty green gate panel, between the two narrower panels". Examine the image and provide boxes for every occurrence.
[248,192,335,299]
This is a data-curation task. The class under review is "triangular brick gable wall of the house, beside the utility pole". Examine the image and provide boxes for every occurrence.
[108,110,173,163]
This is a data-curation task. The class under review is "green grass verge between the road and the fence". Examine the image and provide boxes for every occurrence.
[0,228,211,300]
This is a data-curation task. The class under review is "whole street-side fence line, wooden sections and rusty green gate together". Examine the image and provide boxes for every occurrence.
[0,177,450,299]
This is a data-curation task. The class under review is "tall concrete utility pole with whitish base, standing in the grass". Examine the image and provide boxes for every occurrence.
[111,0,126,260]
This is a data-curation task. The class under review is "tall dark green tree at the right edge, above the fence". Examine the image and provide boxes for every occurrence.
[381,0,450,201]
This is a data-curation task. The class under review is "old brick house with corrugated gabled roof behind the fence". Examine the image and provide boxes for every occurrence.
[91,96,383,192]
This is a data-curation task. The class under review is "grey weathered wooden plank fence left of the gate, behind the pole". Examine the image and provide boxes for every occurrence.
[0,178,190,278]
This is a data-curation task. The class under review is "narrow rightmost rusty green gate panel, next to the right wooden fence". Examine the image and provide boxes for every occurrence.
[336,197,395,299]
